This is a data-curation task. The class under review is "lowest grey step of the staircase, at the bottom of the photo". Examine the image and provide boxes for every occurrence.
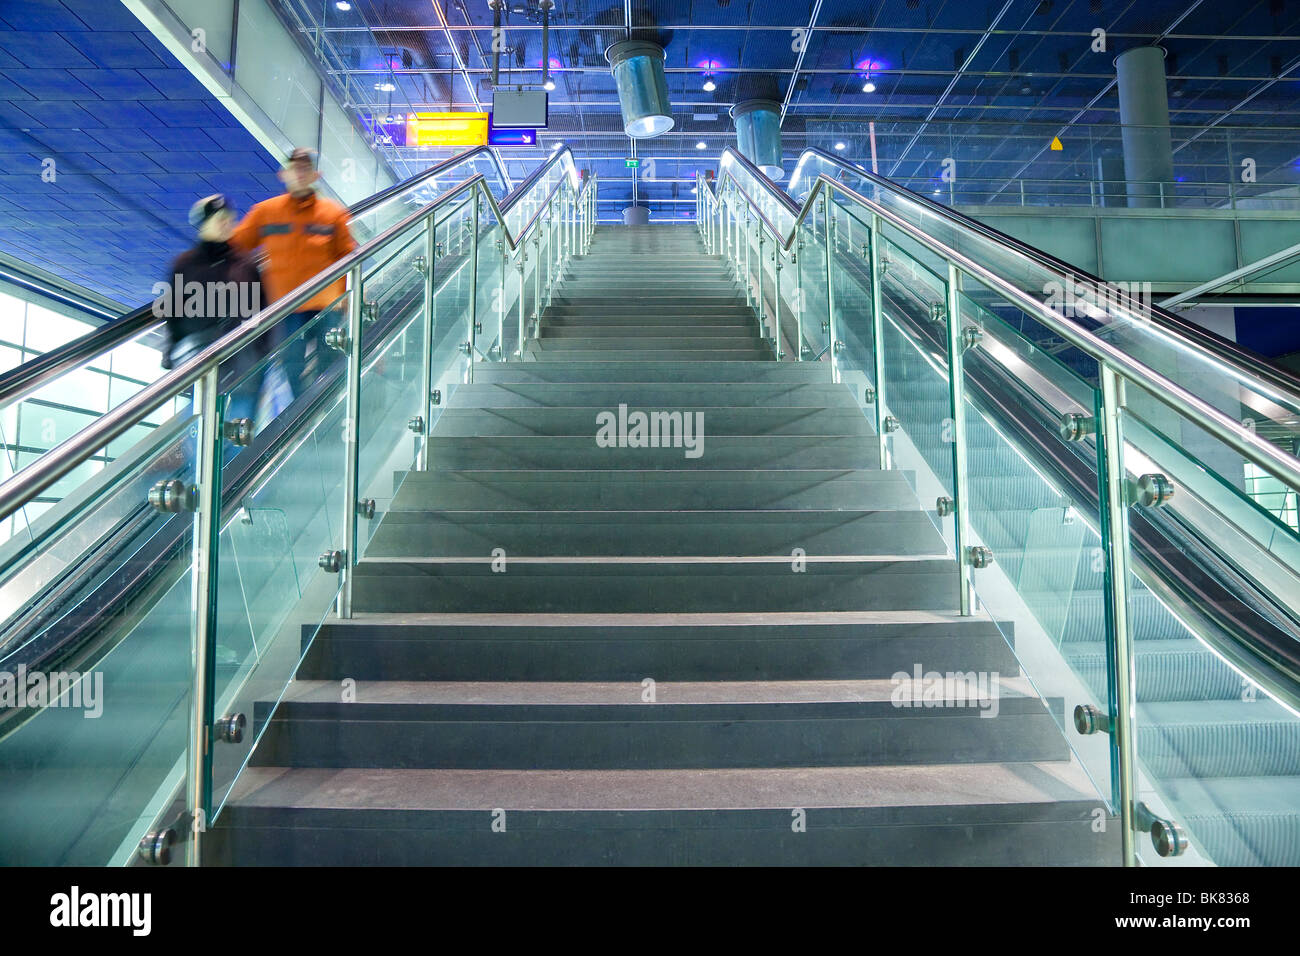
[205,761,1119,866]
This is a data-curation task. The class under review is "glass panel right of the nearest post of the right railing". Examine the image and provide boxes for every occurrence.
[1123,384,1300,866]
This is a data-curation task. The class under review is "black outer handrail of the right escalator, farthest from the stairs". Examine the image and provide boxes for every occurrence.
[783,147,1300,405]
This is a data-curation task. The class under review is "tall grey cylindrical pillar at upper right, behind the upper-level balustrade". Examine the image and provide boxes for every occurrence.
[1115,47,1174,207]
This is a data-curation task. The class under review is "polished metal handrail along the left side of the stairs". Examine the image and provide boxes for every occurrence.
[0,147,585,518]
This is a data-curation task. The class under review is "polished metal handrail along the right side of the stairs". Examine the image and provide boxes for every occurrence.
[715,147,1300,489]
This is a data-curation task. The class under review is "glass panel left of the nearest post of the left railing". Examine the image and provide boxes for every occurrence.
[0,398,198,866]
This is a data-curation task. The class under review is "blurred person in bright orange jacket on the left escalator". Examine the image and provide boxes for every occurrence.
[230,147,356,394]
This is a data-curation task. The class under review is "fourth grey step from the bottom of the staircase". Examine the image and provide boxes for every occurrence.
[352,555,957,614]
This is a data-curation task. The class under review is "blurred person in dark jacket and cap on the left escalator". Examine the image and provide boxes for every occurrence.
[153,194,265,421]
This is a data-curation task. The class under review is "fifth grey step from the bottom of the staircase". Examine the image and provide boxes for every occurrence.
[365,512,944,558]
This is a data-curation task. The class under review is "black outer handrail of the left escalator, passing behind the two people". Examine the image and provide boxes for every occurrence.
[0,146,510,406]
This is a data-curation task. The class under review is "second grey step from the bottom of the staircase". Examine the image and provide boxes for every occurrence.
[254,669,1070,770]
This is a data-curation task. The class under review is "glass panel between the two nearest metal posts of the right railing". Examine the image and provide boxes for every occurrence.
[945,299,1112,797]
